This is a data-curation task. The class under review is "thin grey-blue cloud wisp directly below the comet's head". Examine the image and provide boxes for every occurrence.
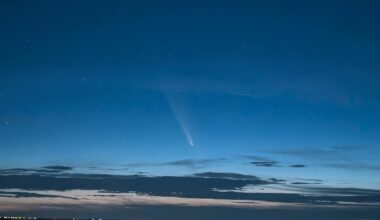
[126,158,227,169]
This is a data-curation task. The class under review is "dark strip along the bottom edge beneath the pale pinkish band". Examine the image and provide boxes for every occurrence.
[0,206,380,220]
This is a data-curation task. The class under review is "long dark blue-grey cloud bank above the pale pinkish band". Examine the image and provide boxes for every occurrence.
[0,172,380,204]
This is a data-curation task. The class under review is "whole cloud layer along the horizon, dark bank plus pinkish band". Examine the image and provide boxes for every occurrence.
[0,165,380,219]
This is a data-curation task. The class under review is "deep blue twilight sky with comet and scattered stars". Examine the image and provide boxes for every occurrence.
[0,0,380,219]
